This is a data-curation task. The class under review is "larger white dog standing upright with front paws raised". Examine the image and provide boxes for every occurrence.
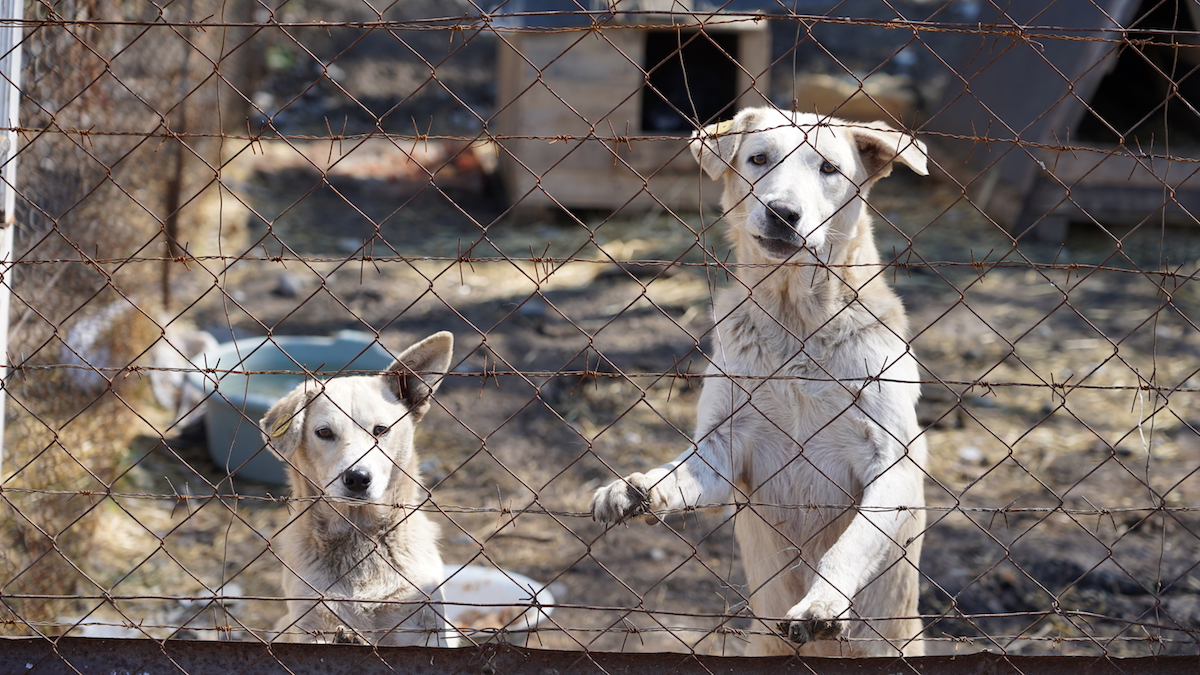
[592,108,926,656]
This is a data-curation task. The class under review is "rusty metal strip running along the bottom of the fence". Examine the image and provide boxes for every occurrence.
[0,638,1200,675]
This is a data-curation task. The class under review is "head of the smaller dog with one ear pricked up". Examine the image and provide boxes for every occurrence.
[260,333,454,502]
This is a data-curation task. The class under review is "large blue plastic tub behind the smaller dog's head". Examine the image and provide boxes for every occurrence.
[187,330,392,484]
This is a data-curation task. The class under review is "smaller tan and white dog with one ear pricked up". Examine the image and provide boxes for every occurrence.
[267,331,454,646]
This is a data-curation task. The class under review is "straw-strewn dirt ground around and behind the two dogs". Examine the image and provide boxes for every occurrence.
[56,141,1200,655]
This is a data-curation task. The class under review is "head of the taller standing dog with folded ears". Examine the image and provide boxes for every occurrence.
[691,108,926,261]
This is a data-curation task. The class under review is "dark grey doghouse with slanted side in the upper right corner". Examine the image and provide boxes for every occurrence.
[925,0,1200,243]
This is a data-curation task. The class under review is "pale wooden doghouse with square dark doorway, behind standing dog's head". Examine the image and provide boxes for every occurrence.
[490,1,770,211]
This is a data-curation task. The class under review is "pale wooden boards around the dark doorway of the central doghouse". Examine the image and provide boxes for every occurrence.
[497,22,770,210]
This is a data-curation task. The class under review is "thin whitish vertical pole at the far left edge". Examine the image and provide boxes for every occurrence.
[0,0,25,483]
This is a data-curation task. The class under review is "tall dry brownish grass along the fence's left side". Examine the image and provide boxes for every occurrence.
[0,0,250,633]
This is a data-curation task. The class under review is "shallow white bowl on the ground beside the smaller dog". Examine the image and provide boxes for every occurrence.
[442,565,554,644]
